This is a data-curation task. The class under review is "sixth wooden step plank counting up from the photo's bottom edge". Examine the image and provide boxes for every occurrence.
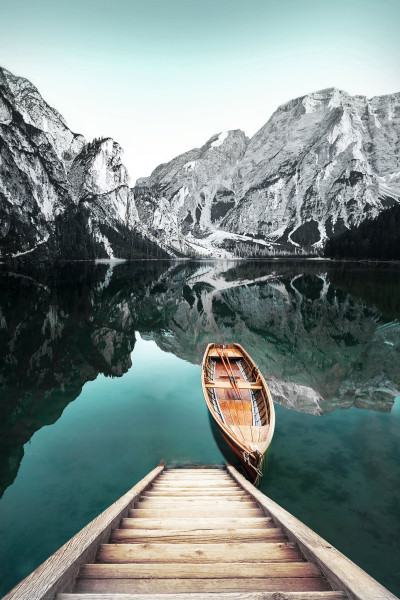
[121,516,275,532]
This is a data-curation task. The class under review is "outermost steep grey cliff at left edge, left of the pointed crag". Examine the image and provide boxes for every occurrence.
[0,69,85,256]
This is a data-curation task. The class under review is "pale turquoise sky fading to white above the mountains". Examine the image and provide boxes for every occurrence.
[0,0,400,185]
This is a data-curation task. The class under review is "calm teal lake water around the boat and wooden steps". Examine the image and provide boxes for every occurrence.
[0,261,400,595]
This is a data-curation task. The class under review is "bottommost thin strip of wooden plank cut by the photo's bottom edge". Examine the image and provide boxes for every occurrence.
[57,591,348,600]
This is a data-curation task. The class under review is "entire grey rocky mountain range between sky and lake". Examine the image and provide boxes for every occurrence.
[0,68,400,259]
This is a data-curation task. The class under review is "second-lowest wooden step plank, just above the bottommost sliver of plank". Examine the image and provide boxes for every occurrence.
[76,577,328,600]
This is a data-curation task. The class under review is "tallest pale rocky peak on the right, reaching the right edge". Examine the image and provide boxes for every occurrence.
[222,89,400,246]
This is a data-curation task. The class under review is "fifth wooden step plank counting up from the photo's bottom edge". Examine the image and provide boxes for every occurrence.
[110,527,286,544]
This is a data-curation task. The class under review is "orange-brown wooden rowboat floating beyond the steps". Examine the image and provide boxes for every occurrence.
[201,344,275,483]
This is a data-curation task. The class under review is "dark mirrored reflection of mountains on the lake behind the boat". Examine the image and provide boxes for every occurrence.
[0,261,400,495]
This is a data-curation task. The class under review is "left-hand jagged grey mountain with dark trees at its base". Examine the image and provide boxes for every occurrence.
[0,68,165,259]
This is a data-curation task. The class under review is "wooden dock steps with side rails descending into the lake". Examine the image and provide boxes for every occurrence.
[3,465,396,600]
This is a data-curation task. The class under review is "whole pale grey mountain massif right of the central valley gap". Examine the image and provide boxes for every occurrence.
[135,88,400,256]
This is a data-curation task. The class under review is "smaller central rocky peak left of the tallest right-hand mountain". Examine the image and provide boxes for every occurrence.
[134,130,248,255]
